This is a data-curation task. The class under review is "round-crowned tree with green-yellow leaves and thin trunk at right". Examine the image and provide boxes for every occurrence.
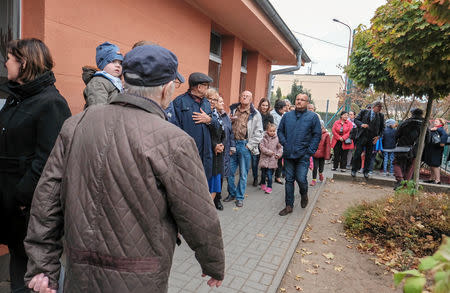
[369,0,450,186]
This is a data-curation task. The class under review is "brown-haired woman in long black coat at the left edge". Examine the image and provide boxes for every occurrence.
[0,39,71,292]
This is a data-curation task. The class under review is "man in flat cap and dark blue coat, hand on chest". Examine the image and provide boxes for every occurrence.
[166,72,219,179]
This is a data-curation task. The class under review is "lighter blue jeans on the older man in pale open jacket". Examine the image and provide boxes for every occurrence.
[228,140,251,200]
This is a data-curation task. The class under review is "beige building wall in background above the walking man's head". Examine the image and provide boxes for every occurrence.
[273,74,345,113]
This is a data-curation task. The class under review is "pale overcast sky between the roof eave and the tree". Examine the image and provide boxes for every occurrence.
[270,0,386,75]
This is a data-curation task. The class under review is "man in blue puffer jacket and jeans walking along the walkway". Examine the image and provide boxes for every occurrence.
[278,94,322,216]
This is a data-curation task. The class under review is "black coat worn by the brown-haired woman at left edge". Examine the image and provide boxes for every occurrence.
[0,71,71,244]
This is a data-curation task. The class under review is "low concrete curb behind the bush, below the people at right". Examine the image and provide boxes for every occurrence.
[333,173,450,193]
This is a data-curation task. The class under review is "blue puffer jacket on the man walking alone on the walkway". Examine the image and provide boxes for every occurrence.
[277,110,322,159]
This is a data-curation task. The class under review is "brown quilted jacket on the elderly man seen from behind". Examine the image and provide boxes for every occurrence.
[25,94,224,293]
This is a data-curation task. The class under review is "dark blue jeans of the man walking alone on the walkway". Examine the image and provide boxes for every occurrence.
[284,155,310,207]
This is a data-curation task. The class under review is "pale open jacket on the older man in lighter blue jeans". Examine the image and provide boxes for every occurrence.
[230,103,264,155]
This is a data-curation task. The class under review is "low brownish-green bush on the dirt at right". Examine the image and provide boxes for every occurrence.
[344,192,450,270]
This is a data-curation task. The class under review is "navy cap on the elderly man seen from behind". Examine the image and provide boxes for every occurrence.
[122,45,184,86]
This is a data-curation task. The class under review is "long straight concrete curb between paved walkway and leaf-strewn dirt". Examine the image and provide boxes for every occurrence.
[266,176,326,293]
